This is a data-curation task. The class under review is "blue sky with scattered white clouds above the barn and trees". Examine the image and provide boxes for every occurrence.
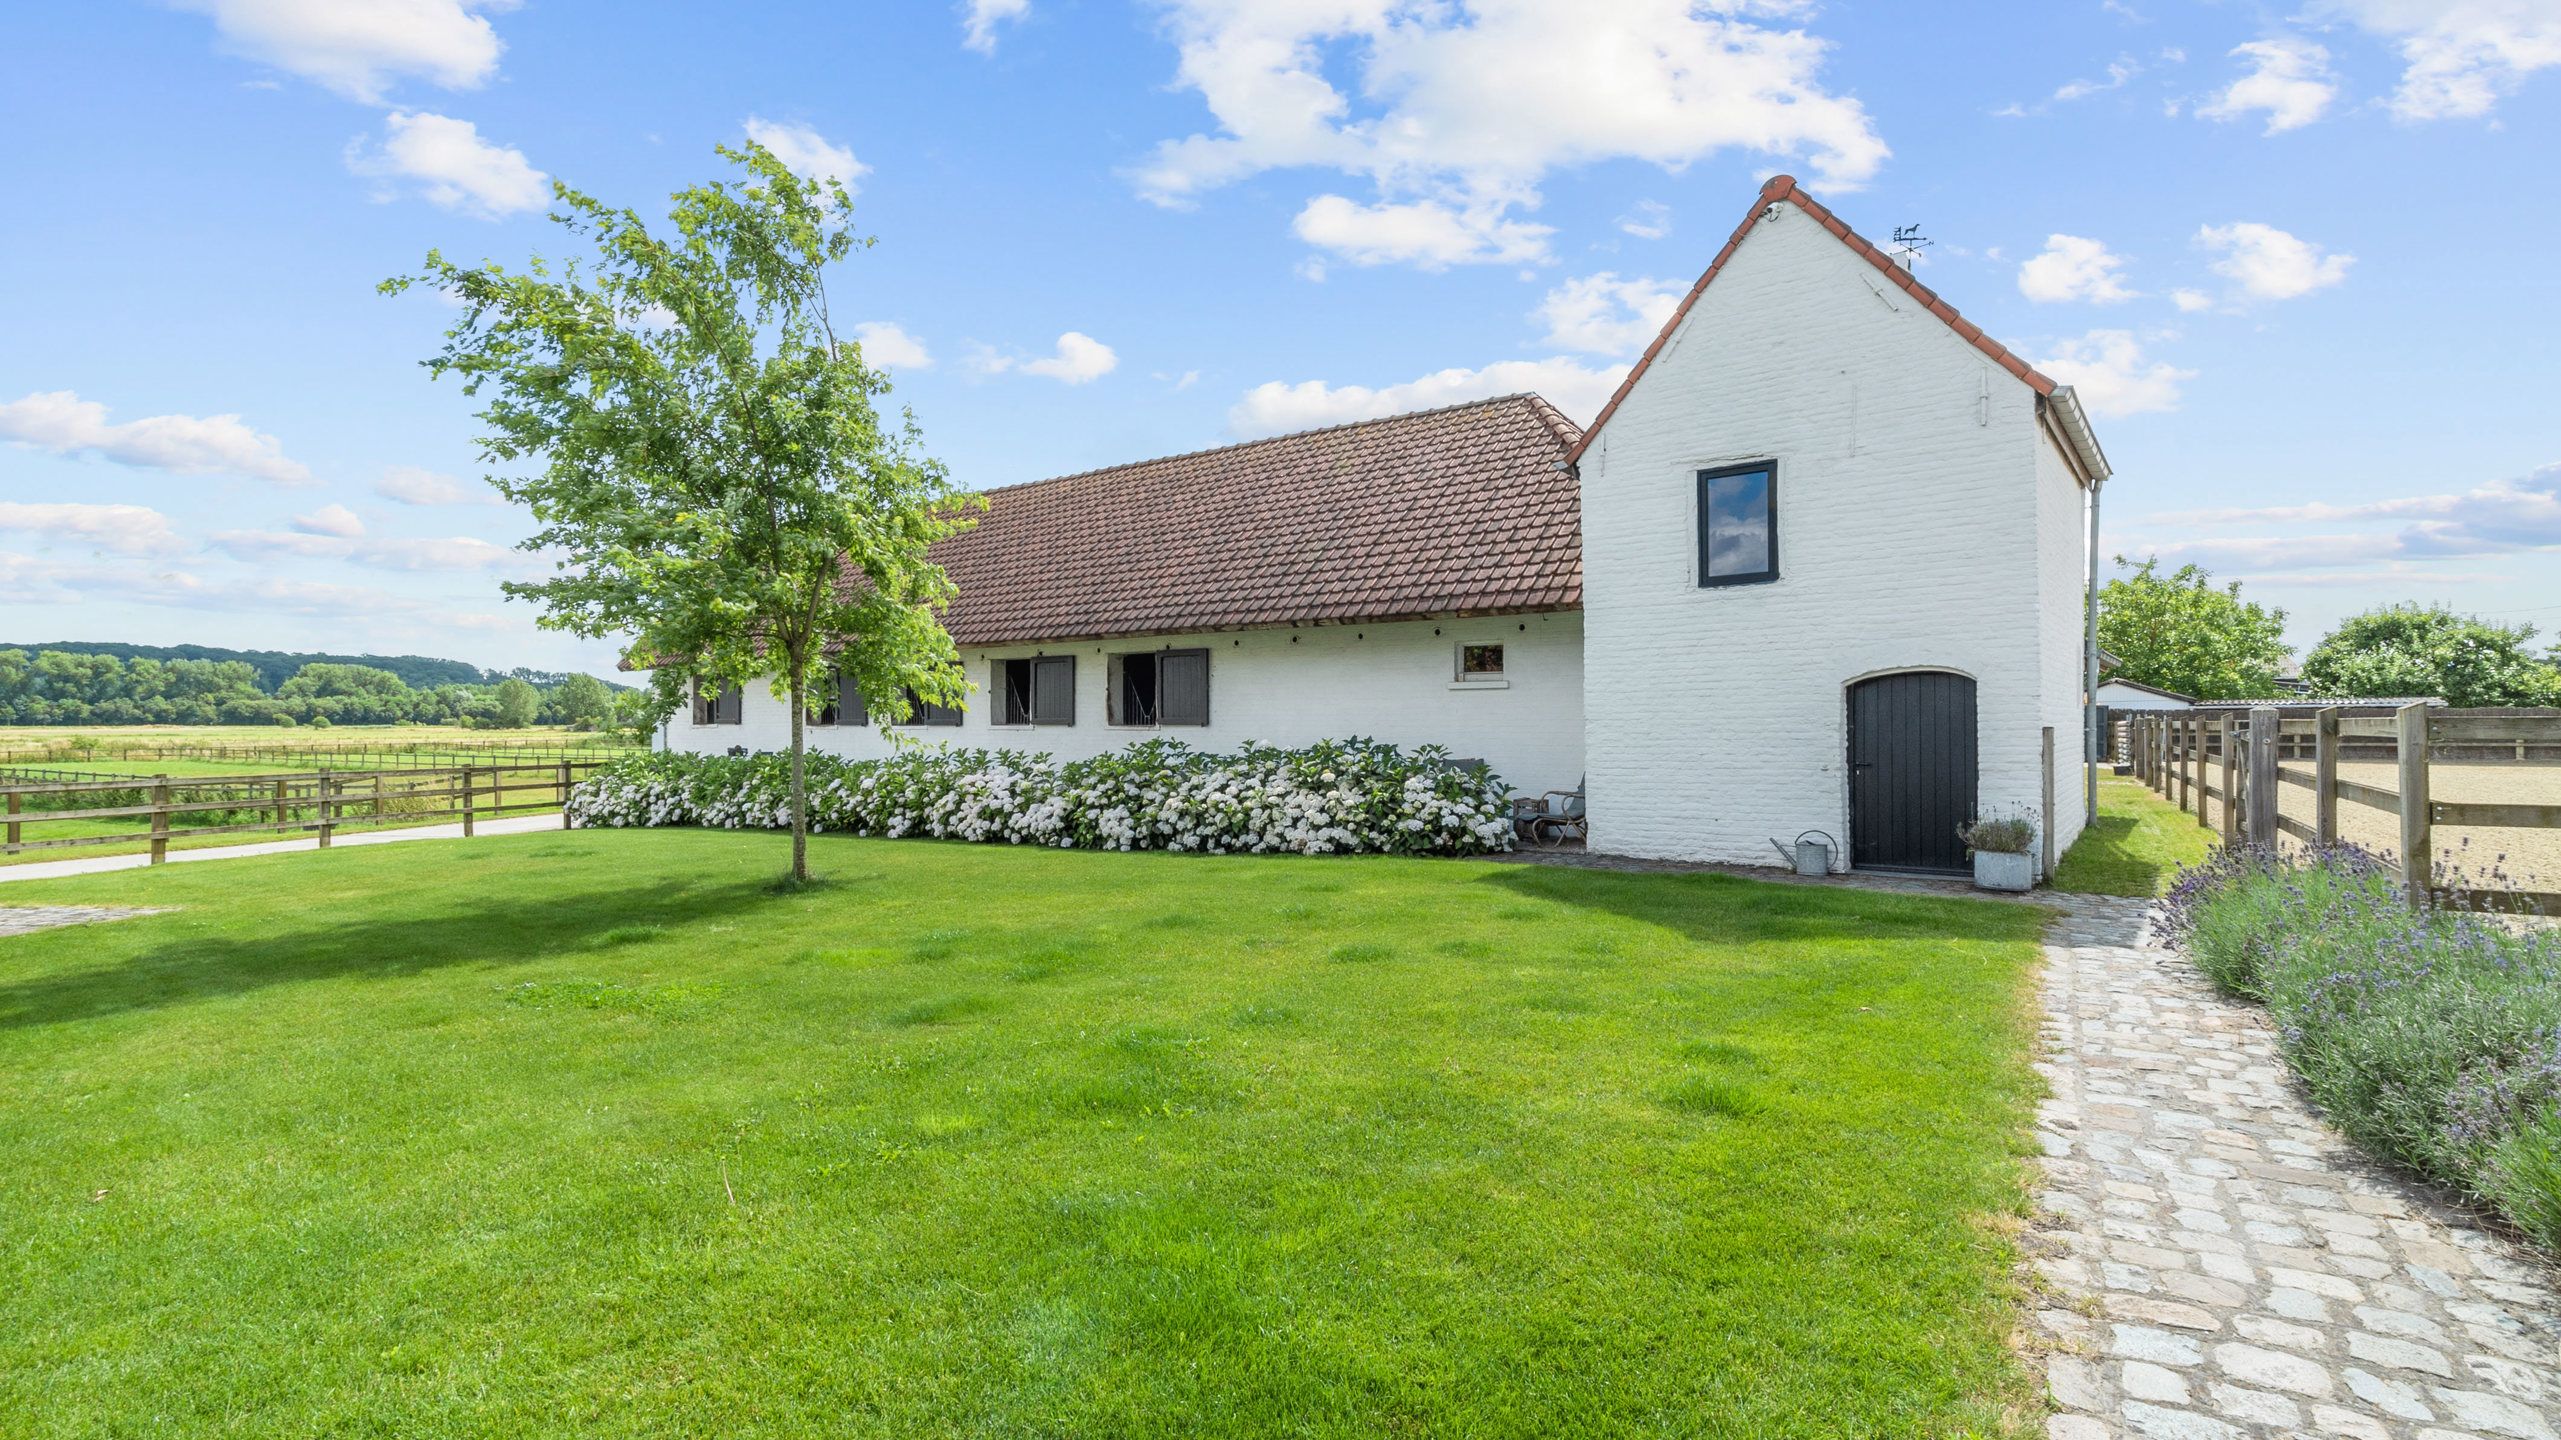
[0,0,2561,671]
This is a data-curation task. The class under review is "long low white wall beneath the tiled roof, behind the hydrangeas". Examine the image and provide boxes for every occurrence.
[666,610,1583,794]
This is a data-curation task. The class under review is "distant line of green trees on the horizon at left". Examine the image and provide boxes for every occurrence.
[0,648,643,730]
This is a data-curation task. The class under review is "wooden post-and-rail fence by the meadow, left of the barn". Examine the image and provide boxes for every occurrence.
[0,758,604,863]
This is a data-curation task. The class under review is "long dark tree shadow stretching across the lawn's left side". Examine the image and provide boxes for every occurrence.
[0,881,773,1030]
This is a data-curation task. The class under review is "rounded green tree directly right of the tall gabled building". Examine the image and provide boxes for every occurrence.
[2097,556,2290,700]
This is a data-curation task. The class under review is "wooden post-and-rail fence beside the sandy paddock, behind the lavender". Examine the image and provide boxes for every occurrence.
[2126,705,2561,915]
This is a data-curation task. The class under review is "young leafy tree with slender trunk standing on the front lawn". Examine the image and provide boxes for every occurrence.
[384,143,973,879]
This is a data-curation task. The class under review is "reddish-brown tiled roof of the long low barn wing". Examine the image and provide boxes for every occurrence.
[911,395,1583,646]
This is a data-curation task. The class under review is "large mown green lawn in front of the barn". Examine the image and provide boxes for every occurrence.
[0,830,2041,1437]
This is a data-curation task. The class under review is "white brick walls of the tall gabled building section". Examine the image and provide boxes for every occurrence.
[1583,205,2082,863]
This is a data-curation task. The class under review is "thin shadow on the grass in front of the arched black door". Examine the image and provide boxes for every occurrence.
[1480,866,2046,945]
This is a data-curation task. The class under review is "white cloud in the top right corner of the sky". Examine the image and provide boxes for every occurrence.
[2320,0,2561,120]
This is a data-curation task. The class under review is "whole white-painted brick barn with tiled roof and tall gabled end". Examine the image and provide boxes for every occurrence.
[663,177,2108,871]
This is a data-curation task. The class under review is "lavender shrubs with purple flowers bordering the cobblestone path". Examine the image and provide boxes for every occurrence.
[2159,846,2561,1248]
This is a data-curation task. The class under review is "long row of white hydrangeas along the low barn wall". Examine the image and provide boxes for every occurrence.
[569,740,1511,856]
